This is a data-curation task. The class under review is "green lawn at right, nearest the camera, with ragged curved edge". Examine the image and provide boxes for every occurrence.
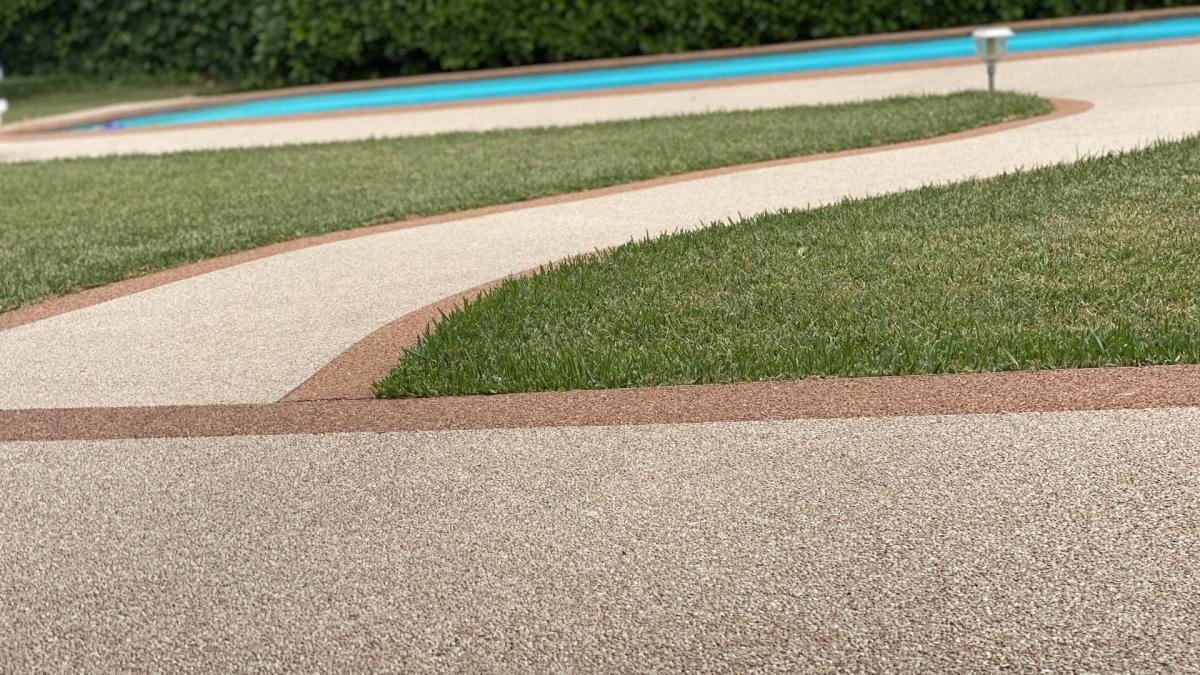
[376,137,1200,398]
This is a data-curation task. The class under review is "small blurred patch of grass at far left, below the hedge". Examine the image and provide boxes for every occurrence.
[0,77,226,124]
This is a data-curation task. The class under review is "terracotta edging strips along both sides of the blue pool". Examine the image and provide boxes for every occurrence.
[0,6,1200,143]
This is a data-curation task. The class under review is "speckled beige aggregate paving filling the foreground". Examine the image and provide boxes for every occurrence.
[0,408,1200,671]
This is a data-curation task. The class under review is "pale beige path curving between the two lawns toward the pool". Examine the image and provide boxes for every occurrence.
[0,46,1200,408]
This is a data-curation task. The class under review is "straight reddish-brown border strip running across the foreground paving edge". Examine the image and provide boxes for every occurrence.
[0,365,1200,441]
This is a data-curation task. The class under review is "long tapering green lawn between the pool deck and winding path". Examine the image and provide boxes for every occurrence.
[0,92,1050,311]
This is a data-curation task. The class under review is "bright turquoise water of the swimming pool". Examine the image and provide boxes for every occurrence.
[84,17,1200,129]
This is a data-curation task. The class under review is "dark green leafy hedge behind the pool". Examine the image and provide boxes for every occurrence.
[0,0,1189,85]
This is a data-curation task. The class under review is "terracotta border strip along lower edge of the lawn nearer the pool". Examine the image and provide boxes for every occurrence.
[0,98,1092,330]
